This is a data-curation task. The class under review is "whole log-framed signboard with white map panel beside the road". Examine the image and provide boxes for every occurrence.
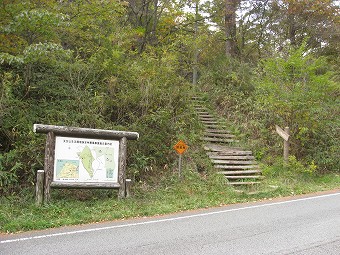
[33,124,139,202]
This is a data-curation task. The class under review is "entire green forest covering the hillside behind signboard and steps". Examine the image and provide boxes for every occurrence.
[0,0,339,192]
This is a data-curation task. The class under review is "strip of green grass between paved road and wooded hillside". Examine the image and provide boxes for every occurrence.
[0,170,340,233]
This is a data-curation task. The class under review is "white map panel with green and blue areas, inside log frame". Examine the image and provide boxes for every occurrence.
[53,136,119,182]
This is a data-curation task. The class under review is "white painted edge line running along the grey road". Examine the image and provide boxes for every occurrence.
[0,193,340,244]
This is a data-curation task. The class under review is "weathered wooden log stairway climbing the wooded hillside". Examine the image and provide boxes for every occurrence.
[192,97,263,186]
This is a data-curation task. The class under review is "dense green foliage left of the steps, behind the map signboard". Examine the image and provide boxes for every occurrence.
[0,1,201,191]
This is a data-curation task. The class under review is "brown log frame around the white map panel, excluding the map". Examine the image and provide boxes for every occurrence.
[33,124,139,203]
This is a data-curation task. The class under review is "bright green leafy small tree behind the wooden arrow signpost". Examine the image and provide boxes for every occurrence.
[256,43,338,157]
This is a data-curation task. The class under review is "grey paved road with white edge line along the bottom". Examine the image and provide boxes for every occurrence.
[0,191,340,255]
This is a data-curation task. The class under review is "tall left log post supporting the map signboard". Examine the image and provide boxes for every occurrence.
[44,132,55,203]
